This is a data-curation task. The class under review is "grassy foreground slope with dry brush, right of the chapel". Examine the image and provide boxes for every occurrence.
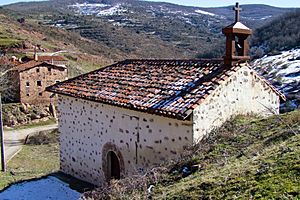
[83,110,300,199]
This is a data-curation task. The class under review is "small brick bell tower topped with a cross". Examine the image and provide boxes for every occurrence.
[222,3,252,66]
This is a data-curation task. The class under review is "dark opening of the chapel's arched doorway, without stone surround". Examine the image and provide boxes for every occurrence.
[107,151,121,180]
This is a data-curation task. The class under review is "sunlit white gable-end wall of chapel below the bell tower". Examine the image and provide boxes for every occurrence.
[193,66,280,142]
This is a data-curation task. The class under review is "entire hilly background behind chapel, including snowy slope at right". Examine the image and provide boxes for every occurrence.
[0,0,300,111]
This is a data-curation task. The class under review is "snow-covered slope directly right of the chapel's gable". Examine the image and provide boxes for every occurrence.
[252,49,300,111]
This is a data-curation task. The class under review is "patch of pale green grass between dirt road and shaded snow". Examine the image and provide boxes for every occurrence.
[0,134,59,190]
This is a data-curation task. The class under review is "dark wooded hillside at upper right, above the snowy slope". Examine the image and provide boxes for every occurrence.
[251,9,300,57]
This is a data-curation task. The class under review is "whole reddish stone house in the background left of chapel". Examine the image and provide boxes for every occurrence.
[6,60,67,104]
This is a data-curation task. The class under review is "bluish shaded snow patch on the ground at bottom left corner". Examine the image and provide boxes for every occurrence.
[0,176,81,200]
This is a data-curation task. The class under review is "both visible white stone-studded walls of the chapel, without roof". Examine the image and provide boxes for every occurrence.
[58,66,279,185]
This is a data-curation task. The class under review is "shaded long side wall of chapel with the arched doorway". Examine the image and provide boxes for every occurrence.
[58,95,193,185]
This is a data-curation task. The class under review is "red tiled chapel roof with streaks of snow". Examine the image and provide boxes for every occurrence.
[47,60,286,119]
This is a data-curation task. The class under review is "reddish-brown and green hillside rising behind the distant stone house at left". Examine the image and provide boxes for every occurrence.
[0,9,121,77]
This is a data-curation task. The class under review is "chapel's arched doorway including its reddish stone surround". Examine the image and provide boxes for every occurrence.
[102,142,125,181]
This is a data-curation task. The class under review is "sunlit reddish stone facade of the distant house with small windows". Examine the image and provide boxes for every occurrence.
[19,65,67,104]
